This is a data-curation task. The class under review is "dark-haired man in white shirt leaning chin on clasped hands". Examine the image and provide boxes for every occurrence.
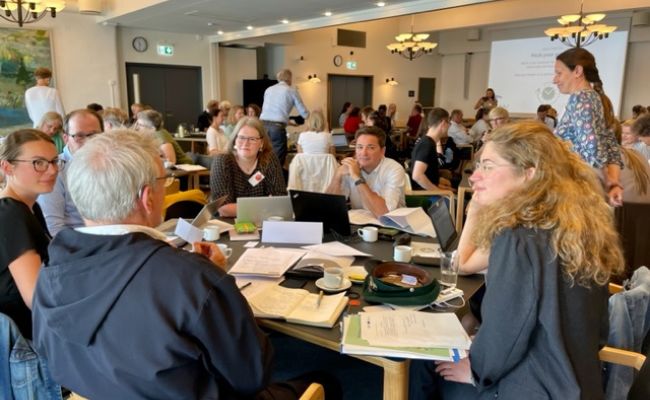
[327,126,406,217]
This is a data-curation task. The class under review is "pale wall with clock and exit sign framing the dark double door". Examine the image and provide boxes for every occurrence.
[116,27,218,108]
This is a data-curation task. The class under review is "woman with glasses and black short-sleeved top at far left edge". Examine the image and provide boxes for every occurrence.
[0,129,63,338]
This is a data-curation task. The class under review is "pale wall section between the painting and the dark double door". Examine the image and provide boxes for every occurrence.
[0,12,120,112]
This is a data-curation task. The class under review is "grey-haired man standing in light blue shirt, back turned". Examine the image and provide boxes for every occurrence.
[260,68,309,166]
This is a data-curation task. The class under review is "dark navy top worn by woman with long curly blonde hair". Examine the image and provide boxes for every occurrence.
[470,228,608,400]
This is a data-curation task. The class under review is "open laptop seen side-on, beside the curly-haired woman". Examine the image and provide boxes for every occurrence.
[413,198,460,265]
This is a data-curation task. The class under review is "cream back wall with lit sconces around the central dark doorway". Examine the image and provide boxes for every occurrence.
[246,19,440,123]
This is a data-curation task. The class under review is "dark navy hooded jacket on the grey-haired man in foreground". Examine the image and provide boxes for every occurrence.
[33,229,272,400]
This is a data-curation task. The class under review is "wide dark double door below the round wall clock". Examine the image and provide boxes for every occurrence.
[126,63,203,132]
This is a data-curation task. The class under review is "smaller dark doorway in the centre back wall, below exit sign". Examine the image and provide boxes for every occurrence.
[327,74,373,129]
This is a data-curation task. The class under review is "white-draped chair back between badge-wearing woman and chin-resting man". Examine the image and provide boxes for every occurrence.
[287,153,338,193]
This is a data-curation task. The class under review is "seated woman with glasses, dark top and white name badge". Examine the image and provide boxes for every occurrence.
[210,117,287,217]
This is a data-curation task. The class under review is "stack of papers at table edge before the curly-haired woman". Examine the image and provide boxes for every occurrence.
[341,311,471,361]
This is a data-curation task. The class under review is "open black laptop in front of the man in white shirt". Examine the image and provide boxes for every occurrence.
[289,190,351,236]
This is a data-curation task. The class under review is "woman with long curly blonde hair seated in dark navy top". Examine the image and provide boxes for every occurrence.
[409,122,624,400]
